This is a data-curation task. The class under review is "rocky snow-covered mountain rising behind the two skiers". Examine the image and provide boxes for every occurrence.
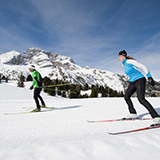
[0,48,159,92]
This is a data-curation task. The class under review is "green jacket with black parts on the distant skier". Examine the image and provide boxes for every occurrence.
[32,70,42,87]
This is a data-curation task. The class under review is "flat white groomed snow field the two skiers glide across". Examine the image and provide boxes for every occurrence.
[0,82,160,160]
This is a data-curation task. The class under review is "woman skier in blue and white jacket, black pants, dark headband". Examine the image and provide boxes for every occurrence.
[118,50,160,124]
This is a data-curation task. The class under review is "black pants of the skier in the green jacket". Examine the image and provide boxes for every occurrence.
[33,88,45,109]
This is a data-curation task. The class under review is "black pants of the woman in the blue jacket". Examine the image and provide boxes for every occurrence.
[124,78,159,118]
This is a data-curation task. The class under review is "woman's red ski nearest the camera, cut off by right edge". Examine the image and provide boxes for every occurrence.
[108,125,160,135]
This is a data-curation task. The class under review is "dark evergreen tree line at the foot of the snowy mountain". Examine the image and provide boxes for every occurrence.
[18,74,124,98]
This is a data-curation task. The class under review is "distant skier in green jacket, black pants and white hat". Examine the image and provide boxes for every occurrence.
[29,65,45,112]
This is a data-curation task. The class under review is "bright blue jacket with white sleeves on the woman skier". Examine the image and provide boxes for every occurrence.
[122,59,152,82]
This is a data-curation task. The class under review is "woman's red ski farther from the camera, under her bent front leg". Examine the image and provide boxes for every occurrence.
[87,118,152,123]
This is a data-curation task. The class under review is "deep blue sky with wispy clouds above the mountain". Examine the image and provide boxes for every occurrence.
[0,0,160,79]
